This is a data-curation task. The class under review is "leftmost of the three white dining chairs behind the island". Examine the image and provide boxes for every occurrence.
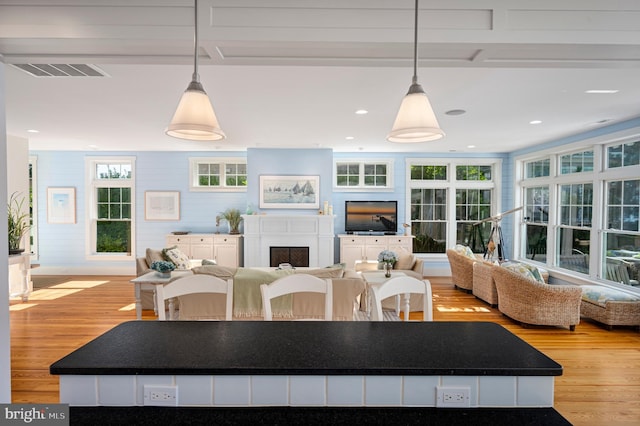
[156,274,233,321]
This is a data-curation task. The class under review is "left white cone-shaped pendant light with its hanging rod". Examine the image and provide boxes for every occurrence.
[166,0,227,141]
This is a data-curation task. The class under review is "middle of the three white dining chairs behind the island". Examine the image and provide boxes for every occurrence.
[260,274,333,321]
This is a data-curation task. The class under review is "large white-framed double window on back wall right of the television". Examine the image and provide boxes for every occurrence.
[407,159,499,253]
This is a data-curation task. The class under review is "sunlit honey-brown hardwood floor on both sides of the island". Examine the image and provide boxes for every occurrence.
[10,276,640,426]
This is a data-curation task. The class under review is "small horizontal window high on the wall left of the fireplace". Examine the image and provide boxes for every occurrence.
[189,157,247,191]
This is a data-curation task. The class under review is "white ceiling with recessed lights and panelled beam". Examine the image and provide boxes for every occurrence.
[0,0,640,152]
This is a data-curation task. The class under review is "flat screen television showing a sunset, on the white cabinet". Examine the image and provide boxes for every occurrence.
[344,201,398,235]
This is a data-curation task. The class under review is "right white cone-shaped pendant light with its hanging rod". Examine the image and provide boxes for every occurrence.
[387,0,444,143]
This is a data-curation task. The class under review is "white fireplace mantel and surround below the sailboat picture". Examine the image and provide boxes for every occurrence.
[242,215,335,267]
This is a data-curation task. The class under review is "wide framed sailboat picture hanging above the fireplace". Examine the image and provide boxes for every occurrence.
[260,176,320,209]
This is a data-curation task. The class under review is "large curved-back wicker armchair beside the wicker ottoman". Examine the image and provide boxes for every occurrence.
[492,267,582,331]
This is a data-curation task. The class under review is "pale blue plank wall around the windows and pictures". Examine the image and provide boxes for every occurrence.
[30,118,640,273]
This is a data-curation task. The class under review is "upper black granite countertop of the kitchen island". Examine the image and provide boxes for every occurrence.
[50,321,562,376]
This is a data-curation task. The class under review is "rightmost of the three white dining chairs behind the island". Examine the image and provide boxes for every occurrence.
[371,275,433,321]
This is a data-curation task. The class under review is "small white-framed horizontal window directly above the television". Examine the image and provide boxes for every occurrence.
[334,160,393,191]
